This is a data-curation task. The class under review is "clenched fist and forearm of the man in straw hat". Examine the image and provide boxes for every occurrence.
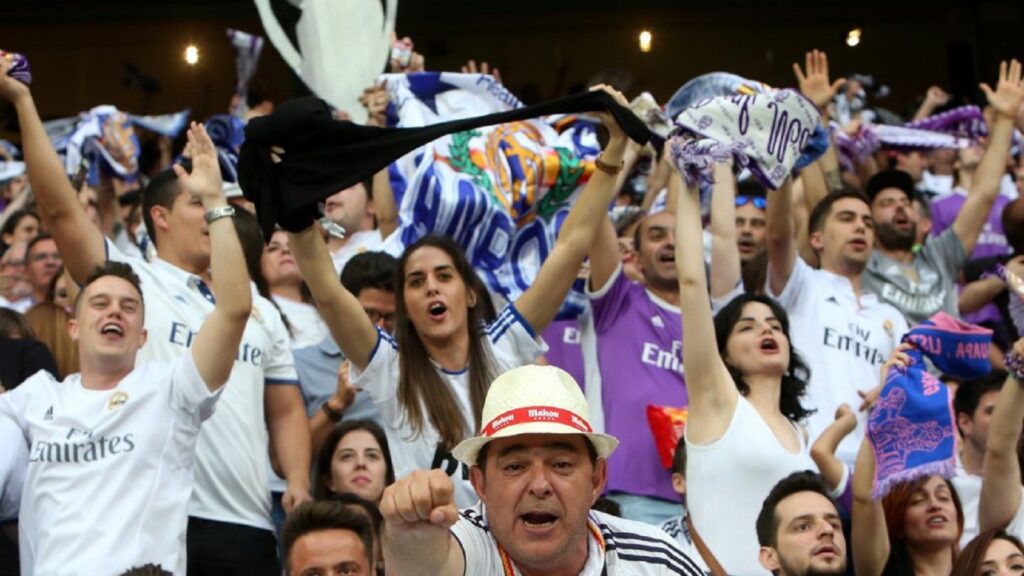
[381,469,466,576]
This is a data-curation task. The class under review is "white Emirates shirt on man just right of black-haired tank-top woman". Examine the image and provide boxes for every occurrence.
[766,257,908,464]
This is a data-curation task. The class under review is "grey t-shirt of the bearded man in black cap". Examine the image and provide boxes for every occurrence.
[862,228,968,327]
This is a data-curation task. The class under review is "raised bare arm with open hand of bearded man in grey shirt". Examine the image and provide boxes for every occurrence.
[952,60,1024,254]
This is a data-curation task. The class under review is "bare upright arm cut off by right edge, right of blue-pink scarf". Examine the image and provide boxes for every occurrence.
[978,340,1024,531]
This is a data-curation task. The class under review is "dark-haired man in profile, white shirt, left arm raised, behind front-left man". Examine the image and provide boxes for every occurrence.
[0,57,311,576]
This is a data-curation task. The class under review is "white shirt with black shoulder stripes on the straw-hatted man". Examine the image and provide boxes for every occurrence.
[451,503,703,576]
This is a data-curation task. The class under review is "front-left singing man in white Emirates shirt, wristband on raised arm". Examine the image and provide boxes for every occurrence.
[0,119,252,575]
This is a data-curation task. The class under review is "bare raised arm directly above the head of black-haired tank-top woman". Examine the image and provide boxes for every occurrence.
[708,162,741,298]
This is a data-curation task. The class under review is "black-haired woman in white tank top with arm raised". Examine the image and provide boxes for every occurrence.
[672,173,815,576]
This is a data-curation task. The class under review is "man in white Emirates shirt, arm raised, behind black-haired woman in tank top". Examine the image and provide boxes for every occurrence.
[767,186,907,464]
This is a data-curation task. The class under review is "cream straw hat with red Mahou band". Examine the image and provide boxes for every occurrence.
[452,365,618,466]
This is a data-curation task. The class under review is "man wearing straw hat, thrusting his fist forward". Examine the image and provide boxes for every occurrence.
[381,366,700,576]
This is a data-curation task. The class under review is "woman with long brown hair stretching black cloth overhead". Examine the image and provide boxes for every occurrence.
[290,84,627,506]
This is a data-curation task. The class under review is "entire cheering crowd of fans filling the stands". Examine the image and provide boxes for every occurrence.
[0,31,1024,576]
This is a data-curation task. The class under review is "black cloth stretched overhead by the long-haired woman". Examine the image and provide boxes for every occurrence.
[239,90,651,240]
